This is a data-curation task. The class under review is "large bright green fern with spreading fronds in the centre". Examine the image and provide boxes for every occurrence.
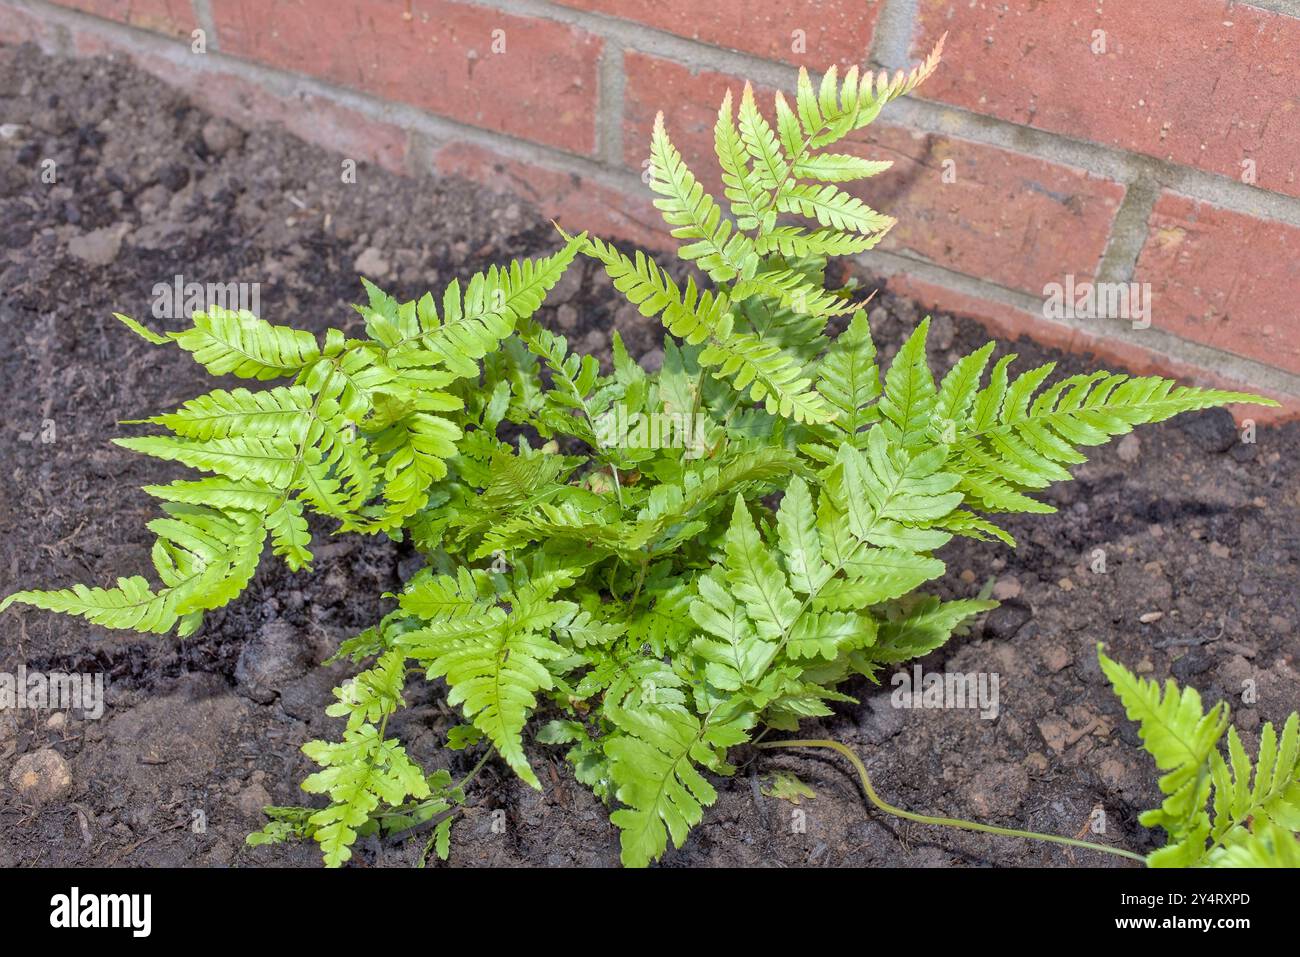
[5,35,1268,866]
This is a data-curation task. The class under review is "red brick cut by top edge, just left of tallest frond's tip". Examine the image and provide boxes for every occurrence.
[558,0,880,70]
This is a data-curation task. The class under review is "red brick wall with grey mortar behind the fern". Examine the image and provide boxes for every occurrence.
[10,0,1300,415]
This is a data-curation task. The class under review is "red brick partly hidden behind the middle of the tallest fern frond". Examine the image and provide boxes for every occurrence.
[624,53,1123,295]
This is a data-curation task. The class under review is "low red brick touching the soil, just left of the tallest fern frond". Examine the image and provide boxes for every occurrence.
[433,143,675,251]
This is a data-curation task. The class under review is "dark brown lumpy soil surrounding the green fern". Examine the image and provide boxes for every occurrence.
[0,47,1300,866]
